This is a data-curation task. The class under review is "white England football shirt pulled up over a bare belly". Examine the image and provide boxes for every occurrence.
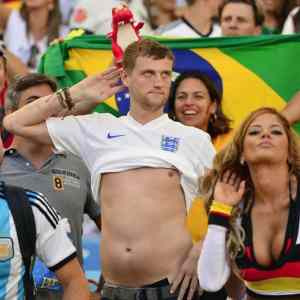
[46,113,215,210]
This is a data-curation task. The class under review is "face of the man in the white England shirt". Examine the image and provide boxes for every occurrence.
[122,56,173,111]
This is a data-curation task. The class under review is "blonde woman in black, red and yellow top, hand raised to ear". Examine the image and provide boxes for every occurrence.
[198,108,300,299]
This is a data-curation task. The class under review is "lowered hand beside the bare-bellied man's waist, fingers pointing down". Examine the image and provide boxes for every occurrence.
[171,241,202,300]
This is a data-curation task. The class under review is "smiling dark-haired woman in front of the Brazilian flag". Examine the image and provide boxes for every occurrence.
[169,71,231,150]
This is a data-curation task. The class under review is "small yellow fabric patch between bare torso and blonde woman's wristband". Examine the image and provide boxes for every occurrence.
[187,198,208,243]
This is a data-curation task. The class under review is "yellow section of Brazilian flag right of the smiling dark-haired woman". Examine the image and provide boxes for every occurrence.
[193,48,286,128]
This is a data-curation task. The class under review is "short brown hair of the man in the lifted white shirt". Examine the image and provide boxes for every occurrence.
[123,39,174,72]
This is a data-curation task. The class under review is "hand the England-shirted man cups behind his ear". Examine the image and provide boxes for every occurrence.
[70,67,124,104]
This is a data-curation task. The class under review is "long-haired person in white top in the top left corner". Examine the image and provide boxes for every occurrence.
[0,0,68,70]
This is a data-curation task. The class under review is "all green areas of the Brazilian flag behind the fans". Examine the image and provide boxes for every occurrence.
[39,34,300,130]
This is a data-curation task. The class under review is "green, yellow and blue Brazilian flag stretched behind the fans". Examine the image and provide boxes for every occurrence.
[40,34,300,132]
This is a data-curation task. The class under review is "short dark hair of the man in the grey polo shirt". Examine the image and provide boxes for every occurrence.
[8,73,57,109]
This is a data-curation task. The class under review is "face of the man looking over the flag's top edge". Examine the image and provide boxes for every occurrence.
[220,3,261,36]
